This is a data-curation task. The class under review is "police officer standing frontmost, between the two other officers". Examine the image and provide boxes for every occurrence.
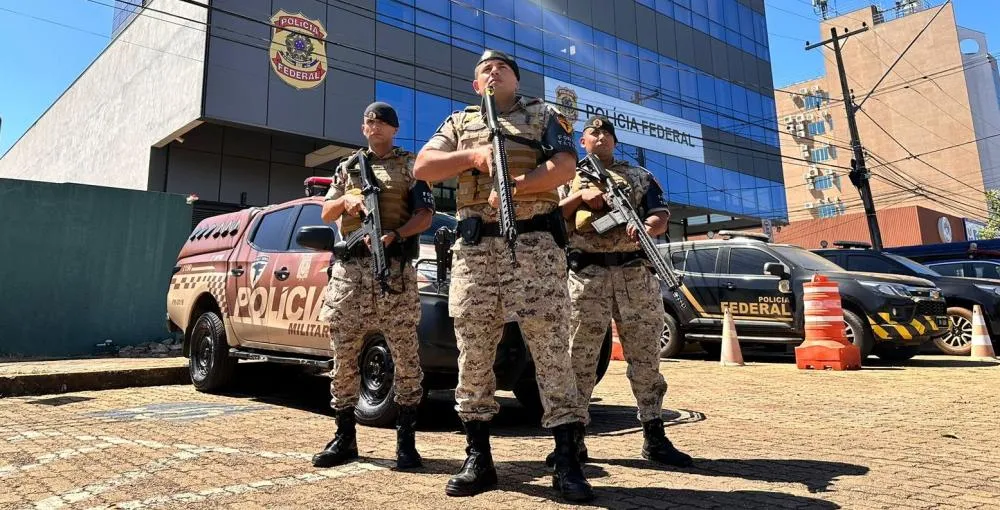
[414,50,593,501]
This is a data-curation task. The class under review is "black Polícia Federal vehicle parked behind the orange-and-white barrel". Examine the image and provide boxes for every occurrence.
[660,231,948,361]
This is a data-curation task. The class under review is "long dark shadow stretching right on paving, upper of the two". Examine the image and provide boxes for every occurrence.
[594,459,868,492]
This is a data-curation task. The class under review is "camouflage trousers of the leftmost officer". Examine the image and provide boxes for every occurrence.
[320,257,424,410]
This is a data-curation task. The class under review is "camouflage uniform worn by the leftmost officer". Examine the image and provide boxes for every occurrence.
[320,148,434,410]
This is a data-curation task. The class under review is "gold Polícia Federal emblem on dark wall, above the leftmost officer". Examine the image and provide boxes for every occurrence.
[270,10,327,89]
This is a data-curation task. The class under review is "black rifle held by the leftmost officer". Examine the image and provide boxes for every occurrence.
[333,149,398,296]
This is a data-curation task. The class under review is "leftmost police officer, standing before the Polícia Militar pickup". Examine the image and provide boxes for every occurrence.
[313,102,434,469]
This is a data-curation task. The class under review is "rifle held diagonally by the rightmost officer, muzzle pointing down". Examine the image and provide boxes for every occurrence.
[577,154,687,308]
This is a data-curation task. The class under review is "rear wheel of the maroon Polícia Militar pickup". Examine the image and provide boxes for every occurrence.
[188,312,236,392]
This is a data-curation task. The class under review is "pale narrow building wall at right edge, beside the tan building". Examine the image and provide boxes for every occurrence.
[958,27,1000,189]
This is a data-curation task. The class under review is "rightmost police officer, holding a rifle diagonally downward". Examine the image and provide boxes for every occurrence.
[560,116,692,467]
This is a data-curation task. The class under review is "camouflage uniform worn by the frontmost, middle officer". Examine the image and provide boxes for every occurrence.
[424,98,586,428]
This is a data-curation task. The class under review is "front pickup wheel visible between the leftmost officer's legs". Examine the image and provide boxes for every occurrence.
[354,336,399,427]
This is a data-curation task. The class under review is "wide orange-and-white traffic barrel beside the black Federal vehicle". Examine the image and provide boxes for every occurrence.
[795,274,861,370]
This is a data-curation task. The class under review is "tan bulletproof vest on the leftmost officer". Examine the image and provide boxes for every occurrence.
[340,149,411,236]
